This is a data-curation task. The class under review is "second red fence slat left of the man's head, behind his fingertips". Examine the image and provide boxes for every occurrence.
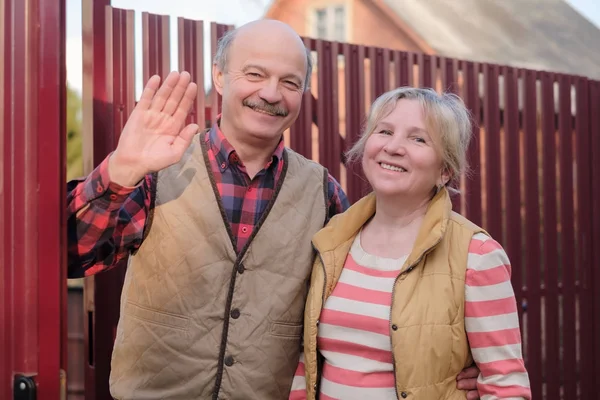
[177,17,206,129]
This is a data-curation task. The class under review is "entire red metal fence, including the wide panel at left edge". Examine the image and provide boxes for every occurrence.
[0,0,600,399]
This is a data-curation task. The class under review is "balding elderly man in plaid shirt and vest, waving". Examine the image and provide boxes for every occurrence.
[68,20,476,399]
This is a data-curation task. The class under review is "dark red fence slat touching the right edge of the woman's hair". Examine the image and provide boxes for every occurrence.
[463,61,482,226]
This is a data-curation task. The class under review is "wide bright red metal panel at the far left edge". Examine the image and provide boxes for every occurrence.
[0,0,67,399]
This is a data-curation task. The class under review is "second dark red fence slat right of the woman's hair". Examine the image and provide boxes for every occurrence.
[483,64,503,241]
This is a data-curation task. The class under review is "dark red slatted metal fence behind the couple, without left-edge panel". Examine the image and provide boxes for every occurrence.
[78,3,600,399]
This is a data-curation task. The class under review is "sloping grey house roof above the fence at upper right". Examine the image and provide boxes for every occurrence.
[382,0,600,79]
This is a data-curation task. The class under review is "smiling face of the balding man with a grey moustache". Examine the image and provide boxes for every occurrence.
[213,30,307,144]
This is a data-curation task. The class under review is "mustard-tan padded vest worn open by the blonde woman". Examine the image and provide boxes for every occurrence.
[304,189,484,400]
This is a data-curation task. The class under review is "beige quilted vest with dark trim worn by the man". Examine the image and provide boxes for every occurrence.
[107,134,327,400]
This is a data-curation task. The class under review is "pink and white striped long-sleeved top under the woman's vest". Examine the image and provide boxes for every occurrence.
[290,234,531,400]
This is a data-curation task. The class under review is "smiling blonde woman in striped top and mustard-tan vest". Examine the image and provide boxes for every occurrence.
[290,88,531,400]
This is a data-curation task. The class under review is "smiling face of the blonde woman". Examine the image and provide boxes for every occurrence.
[362,99,449,201]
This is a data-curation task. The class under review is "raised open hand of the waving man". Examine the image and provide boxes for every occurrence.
[109,72,199,186]
